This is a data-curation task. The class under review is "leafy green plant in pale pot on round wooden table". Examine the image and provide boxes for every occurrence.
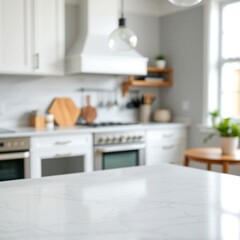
[204,118,240,155]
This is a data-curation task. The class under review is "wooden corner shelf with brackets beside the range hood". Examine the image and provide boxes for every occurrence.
[122,67,173,96]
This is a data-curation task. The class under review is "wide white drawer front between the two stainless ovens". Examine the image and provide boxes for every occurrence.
[31,134,92,150]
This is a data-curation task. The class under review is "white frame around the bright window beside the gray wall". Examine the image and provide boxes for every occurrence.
[202,0,240,125]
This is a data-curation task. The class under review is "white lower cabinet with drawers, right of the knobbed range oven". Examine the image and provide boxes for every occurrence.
[146,129,186,166]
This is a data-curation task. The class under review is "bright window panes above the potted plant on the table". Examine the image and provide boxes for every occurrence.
[218,0,240,118]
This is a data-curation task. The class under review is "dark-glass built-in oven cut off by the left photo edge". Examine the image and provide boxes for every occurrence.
[0,137,30,181]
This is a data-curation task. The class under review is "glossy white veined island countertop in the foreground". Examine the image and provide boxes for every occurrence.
[0,165,240,240]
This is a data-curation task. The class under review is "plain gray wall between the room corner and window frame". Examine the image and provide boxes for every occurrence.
[160,6,210,147]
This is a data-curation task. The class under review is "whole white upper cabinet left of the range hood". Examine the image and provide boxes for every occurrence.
[0,0,65,75]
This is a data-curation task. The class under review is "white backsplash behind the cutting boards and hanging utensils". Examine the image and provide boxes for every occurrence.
[0,75,159,128]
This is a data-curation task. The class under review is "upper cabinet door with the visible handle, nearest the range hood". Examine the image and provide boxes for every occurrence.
[34,0,65,75]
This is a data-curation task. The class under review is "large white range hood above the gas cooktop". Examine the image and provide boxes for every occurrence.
[66,0,148,75]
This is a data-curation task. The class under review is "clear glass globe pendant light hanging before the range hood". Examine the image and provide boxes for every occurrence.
[108,0,137,51]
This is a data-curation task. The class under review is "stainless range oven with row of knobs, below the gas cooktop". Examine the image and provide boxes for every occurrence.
[94,131,145,170]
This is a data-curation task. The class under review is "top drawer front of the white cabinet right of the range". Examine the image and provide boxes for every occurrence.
[147,129,186,142]
